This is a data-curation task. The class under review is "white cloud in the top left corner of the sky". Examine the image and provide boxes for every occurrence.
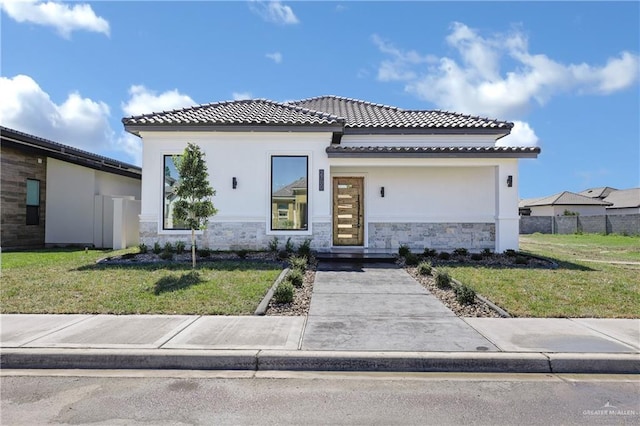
[0,0,110,38]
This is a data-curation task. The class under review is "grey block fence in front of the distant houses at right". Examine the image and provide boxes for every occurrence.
[520,214,640,235]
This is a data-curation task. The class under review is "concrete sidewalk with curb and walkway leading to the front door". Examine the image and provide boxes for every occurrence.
[0,265,640,373]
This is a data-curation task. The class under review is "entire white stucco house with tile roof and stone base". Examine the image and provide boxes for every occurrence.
[123,96,540,252]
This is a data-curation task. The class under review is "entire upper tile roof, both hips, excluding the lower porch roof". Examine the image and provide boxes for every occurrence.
[122,96,513,135]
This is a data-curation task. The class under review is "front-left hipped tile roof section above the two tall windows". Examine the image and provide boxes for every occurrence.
[122,99,344,126]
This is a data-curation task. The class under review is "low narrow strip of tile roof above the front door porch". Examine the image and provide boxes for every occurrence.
[326,145,540,158]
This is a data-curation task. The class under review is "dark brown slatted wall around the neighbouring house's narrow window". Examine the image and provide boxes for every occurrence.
[0,146,47,249]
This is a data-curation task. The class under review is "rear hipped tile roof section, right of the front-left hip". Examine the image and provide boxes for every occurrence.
[288,95,513,130]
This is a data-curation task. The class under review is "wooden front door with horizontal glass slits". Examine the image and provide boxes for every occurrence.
[333,177,364,246]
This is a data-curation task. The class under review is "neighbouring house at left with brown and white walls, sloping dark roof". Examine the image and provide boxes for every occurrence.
[0,126,142,249]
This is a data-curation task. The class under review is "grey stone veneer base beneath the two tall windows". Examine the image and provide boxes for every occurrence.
[140,222,331,250]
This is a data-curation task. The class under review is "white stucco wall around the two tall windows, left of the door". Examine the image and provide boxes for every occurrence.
[141,132,331,233]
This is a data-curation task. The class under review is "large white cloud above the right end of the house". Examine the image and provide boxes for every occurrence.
[373,23,640,119]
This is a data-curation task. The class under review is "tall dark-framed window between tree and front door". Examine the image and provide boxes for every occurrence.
[271,155,309,231]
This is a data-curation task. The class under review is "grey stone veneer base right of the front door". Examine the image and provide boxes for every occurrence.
[369,223,496,251]
